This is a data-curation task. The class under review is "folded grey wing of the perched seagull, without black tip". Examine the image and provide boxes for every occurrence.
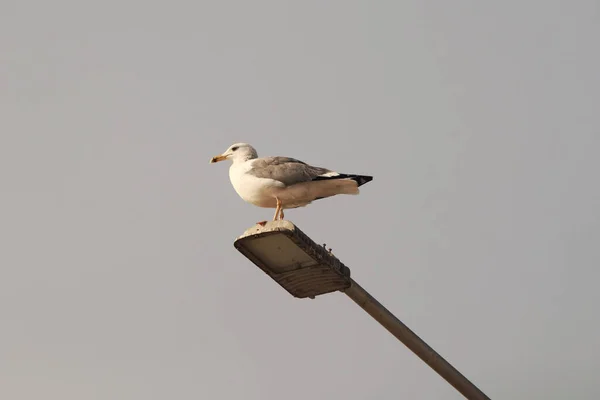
[248,157,332,186]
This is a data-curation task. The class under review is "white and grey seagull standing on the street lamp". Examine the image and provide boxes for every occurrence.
[210,143,373,221]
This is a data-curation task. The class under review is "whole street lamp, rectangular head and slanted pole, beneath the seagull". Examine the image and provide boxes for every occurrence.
[234,220,489,400]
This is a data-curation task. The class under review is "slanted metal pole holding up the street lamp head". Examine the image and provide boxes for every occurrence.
[344,280,490,400]
